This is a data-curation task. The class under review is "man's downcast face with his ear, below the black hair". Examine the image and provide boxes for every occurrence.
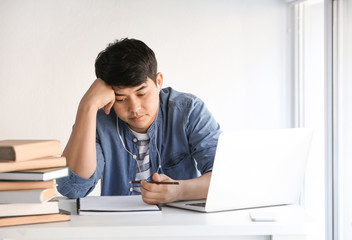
[113,74,162,133]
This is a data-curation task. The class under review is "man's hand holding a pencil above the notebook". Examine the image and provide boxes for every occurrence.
[141,173,182,204]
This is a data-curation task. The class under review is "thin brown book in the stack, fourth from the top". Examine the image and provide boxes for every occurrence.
[0,180,56,191]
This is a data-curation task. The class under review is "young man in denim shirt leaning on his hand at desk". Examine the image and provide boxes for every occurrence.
[57,39,220,204]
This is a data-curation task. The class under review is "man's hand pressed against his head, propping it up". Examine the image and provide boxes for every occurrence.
[80,78,115,114]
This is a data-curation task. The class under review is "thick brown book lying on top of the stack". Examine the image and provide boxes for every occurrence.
[0,139,62,161]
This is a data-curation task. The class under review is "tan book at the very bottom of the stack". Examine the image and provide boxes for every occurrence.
[0,209,70,227]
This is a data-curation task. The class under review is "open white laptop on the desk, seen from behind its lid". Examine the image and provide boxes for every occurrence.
[167,128,313,212]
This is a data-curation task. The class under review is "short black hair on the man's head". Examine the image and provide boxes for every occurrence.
[95,38,157,87]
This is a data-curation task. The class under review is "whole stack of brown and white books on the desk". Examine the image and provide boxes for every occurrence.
[0,140,70,227]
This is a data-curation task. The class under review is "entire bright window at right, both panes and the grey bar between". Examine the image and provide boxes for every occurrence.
[291,0,352,240]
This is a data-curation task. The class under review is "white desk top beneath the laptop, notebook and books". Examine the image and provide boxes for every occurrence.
[0,199,309,240]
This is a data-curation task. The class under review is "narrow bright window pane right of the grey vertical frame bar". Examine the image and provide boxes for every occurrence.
[332,0,352,240]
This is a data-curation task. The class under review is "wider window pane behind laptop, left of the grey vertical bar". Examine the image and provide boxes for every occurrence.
[291,0,326,239]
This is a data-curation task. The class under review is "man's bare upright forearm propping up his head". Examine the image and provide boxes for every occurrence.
[63,104,97,178]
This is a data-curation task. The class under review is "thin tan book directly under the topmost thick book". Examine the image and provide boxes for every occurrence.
[0,157,66,172]
